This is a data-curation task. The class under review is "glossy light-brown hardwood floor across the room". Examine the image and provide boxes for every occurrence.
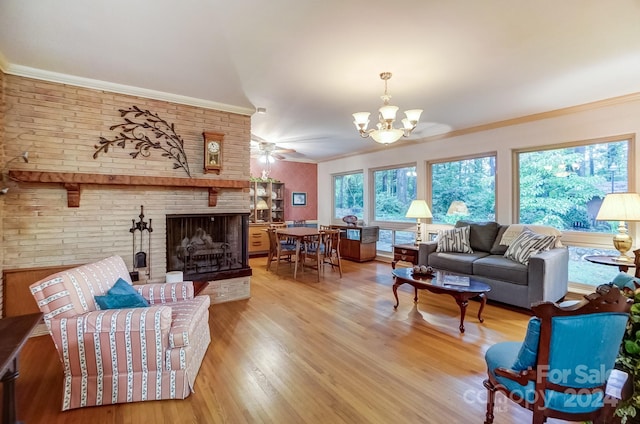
[6,258,584,424]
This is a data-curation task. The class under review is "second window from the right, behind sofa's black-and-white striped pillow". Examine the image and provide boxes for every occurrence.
[429,153,496,224]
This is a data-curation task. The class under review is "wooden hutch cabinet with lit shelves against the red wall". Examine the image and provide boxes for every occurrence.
[249,181,285,255]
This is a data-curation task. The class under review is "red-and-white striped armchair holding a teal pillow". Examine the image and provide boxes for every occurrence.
[30,256,211,411]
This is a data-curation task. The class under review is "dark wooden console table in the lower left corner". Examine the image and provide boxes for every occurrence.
[0,312,42,424]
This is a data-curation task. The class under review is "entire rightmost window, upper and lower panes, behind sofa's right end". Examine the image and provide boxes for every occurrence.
[514,135,634,286]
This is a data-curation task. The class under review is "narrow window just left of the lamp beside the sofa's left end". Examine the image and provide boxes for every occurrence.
[373,165,416,222]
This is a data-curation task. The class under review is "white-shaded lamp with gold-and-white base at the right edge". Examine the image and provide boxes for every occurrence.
[596,193,640,262]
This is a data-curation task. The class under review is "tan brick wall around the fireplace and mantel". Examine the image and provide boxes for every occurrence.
[0,72,251,314]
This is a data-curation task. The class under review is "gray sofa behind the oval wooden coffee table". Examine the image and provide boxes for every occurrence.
[418,221,569,309]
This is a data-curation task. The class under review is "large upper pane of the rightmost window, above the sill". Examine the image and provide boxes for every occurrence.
[516,139,630,233]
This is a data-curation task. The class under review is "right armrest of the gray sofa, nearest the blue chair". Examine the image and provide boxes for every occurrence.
[529,247,569,304]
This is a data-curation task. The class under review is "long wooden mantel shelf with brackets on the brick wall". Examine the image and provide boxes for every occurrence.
[9,170,249,208]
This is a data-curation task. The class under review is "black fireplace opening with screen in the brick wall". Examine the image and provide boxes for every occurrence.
[167,213,251,281]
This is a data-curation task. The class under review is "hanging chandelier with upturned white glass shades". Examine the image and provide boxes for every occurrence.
[353,72,422,144]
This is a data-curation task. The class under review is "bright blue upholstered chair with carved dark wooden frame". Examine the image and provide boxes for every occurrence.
[483,285,633,424]
